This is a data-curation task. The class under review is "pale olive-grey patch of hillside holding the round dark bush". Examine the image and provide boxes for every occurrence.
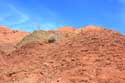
[16,30,71,47]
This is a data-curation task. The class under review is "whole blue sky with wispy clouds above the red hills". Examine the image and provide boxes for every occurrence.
[0,0,125,33]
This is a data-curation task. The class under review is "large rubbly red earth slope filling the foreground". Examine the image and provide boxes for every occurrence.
[0,28,125,83]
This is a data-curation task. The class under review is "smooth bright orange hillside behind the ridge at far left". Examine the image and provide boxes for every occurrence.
[0,26,29,52]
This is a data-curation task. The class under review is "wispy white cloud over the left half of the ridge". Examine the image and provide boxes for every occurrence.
[0,2,61,31]
